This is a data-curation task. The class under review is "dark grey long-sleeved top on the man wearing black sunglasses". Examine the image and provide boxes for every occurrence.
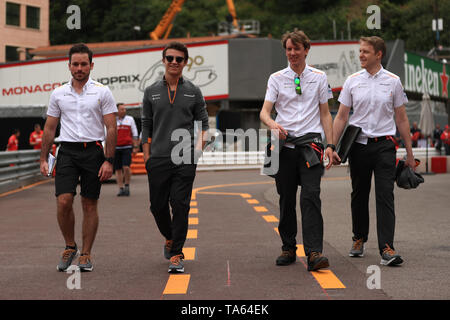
[142,78,209,158]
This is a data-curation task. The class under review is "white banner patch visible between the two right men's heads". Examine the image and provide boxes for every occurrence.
[306,41,361,90]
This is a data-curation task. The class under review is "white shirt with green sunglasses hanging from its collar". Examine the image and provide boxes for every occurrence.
[265,65,333,137]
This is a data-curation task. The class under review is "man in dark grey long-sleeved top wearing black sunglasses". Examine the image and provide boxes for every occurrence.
[142,42,208,272]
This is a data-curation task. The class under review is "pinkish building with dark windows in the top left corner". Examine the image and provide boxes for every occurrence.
[0,0,50,63]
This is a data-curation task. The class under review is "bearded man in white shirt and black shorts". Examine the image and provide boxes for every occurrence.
[40,44,117,271]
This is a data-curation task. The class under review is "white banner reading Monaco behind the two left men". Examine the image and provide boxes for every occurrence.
[0,41,229,105]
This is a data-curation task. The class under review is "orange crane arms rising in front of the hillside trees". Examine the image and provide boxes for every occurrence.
[150,0,243,40]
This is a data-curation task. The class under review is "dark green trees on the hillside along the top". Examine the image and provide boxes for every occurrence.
[50,0,450,51]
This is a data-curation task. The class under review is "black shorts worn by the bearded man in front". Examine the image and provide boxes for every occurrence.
[55,141,105,199]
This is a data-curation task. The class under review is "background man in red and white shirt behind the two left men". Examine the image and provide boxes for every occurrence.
[114,103,139,197]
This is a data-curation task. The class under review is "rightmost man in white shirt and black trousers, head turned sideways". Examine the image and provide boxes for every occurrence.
[333,36,415,265]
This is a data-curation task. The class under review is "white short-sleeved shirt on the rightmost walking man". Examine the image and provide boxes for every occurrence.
[338,67,408,144]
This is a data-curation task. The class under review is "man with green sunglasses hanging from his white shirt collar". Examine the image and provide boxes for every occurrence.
[260,30,334,271]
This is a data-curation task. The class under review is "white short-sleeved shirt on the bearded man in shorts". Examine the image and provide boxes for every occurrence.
[47,78,117,142]
